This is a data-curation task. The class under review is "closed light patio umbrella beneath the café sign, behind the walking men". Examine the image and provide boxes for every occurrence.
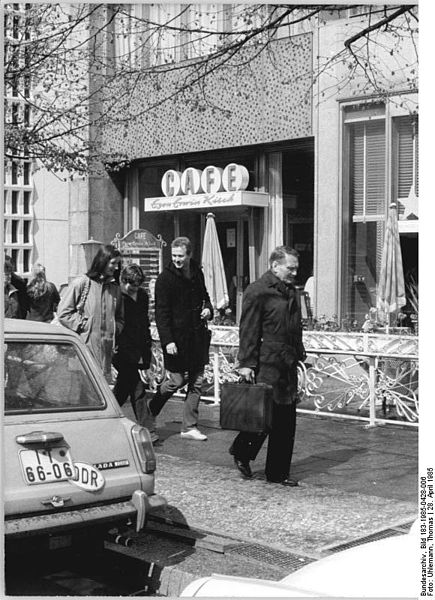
[202,213,229,309]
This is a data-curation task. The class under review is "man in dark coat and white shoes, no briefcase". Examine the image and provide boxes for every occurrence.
[148,237,213,441]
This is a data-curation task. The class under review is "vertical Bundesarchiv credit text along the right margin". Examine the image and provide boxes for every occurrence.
[420,467,433,596]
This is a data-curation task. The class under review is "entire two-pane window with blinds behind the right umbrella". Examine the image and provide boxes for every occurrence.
[342,105,418,323]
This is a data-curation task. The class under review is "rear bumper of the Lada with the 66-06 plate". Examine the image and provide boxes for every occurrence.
[4,490,167,538]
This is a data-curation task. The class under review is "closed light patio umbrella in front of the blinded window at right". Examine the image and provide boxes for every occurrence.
[377,203,406,325]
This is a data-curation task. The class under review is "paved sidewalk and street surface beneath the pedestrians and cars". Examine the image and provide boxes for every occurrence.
[6,398,418,596]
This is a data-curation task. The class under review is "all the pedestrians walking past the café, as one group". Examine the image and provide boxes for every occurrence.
[4,237,305,487]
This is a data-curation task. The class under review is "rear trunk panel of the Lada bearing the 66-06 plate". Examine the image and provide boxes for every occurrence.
[4,407,146,518]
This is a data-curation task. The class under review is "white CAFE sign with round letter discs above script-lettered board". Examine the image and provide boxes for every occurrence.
[144,163,269,212]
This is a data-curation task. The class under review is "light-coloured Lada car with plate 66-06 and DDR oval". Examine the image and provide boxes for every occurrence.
[3,319,166,550]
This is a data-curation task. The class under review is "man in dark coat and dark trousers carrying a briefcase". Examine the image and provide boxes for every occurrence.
[230,246,305,486]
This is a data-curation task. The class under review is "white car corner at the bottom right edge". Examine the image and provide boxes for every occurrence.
[180,523,419,598]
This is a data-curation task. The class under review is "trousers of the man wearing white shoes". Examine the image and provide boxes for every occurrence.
[148,368,204,431]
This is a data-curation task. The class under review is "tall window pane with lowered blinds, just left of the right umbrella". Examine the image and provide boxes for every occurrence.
[342,108,387,324]
